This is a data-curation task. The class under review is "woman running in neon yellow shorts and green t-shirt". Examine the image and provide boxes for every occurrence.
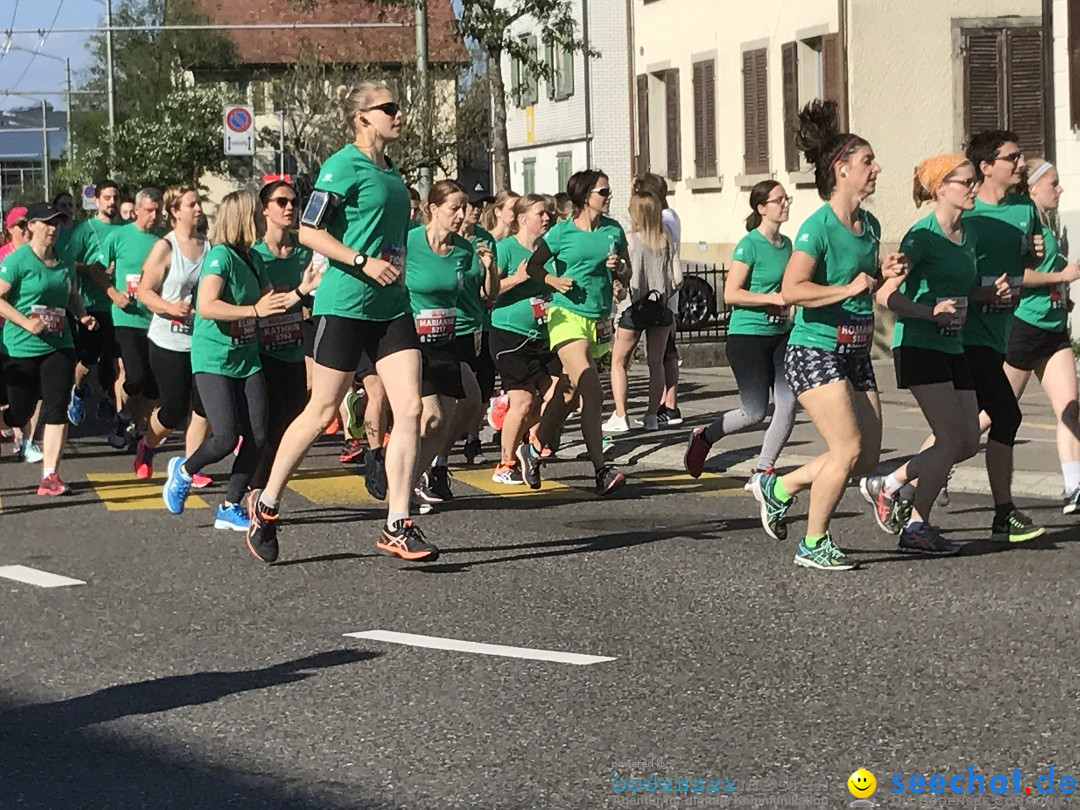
[517,170,630,496]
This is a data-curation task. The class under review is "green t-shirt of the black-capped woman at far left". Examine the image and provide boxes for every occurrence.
[0,244,76,357]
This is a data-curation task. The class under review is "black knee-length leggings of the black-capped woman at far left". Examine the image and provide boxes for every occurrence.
[3,349,75,428]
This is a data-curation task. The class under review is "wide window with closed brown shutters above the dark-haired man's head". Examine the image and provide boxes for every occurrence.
[961,26,1047,154]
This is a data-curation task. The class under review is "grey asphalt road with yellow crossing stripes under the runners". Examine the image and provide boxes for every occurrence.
[0,390,1080,809]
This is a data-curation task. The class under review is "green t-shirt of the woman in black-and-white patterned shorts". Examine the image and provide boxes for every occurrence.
[788,203,881,353]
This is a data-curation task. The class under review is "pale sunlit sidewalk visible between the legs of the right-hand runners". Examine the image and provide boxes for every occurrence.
[596,361,1062,499]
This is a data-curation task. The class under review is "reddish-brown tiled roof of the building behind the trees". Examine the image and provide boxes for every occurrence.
[193,0,470,65]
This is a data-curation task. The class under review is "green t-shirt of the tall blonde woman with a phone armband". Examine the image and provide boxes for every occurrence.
[312,144,409,321]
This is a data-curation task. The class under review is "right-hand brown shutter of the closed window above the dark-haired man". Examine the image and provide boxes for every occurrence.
[1005,27,1047,157]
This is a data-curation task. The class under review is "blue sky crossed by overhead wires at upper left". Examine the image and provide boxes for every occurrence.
[0,0,104,109]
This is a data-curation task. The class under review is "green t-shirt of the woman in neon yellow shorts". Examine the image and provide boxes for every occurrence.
[542,216,626,320]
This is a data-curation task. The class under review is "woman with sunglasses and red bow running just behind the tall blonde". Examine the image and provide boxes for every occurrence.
[252,180,320,489]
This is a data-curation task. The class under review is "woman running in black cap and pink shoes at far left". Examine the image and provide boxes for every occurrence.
[0,203,96,496]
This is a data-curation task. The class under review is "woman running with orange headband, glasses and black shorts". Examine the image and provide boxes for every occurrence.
[860,154,989,556]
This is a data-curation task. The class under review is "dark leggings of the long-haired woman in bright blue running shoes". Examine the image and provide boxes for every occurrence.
[184,372,268,503]
